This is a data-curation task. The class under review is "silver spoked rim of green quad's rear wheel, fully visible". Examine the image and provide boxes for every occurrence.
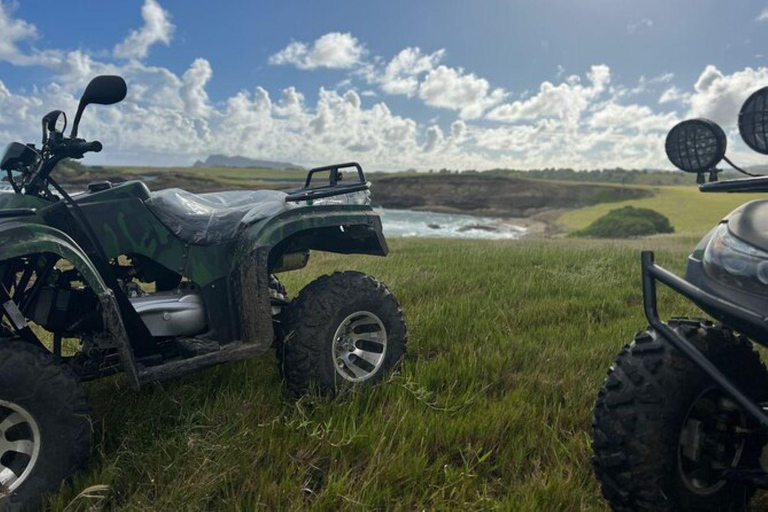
[331,311,387,382]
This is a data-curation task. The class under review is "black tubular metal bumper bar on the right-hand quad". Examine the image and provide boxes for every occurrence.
[641,251,768,428]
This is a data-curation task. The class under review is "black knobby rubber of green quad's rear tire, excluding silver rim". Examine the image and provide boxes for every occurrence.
[277,272,408,394]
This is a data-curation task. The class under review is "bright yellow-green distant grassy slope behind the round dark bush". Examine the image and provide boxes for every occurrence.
[556,187,765,235]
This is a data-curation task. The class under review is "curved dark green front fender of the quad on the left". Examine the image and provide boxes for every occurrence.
[0,219,139,387]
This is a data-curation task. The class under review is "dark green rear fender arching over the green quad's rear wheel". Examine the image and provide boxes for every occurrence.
[231,205,389,351]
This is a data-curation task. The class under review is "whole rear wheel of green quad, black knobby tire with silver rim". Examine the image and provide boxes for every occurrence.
[277,272,408,394]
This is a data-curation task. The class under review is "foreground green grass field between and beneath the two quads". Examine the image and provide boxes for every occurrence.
[45,237,752,511]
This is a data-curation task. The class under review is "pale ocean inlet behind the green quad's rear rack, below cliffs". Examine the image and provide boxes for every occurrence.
[377,208,526,240]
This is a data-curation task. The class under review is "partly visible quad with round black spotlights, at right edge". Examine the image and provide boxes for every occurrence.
[592,87,768,511]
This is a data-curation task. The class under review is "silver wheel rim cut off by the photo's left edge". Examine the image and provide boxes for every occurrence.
[0,400,40,494]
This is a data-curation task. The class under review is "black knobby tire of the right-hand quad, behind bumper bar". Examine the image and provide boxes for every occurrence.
[592,319,768,511]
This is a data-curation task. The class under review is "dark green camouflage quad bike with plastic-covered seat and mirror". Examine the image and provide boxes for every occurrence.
[0,76,407,510]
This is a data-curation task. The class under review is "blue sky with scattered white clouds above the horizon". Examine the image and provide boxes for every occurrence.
[0,0,768,170]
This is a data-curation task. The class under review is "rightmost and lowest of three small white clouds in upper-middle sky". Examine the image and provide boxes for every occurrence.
[419,65,507,119]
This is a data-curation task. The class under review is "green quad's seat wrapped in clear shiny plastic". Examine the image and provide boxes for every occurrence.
[146,188,295,245]
